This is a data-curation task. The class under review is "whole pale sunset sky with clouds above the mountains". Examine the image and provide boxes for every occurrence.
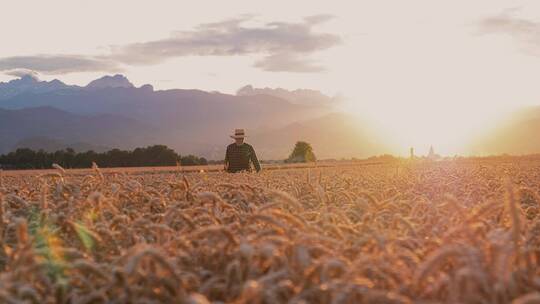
[0,0,540,154]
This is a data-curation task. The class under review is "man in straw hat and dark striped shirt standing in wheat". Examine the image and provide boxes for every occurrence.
[225,129,261,173]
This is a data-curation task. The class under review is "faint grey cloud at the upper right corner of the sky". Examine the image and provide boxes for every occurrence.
[479,9,540,55]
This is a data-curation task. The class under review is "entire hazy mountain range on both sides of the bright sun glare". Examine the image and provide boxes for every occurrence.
[0,75,540,159]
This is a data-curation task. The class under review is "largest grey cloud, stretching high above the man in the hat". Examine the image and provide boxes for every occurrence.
[112,15,341,72]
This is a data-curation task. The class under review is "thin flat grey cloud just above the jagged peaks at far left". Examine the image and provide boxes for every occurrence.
[0,55,120,74]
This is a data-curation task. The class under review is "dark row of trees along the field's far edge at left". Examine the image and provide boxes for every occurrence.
[0,145,208,169]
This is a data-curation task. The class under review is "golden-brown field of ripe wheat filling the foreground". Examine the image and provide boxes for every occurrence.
[0,161,540,304]
